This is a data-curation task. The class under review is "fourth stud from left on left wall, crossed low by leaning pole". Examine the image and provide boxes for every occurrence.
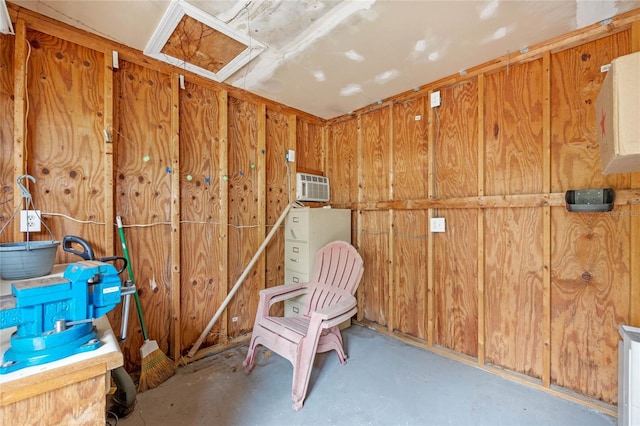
[212,90,229,344]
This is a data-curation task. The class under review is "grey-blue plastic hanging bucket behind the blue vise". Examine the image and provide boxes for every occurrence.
[0,241,60,280]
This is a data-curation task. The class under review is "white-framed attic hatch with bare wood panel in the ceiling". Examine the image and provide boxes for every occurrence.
[144,0,267,82]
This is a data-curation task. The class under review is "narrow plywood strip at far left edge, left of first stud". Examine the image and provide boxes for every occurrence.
[0,34,13,242]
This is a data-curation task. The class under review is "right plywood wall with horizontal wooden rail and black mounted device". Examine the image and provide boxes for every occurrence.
[326,15,640,404]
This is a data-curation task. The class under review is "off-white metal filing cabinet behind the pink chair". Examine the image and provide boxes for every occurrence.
[284,207,351,316]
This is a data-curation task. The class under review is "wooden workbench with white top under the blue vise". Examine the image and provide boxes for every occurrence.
[0,266,123,426]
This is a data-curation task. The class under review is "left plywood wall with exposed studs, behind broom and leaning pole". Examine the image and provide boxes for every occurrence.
[0,11,325,370]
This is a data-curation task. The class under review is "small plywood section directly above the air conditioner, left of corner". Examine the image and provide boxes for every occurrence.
[296,118,324,174]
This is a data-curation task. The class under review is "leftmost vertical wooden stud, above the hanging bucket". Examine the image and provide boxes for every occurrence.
[13,19,29,241]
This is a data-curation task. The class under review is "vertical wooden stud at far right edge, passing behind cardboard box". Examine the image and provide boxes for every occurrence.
[629,21,640,327]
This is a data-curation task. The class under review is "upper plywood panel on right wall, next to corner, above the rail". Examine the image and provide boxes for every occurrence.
[327,118,358,204]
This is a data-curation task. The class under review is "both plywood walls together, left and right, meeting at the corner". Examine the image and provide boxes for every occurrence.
[0,4,640,410]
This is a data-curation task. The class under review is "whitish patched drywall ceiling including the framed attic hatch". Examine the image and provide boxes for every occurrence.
[8,0,640,119]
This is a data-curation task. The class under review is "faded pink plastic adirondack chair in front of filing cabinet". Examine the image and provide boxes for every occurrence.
[243,241,364,411]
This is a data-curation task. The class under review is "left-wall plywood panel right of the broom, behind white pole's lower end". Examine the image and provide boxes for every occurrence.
[180,81,222,349]
